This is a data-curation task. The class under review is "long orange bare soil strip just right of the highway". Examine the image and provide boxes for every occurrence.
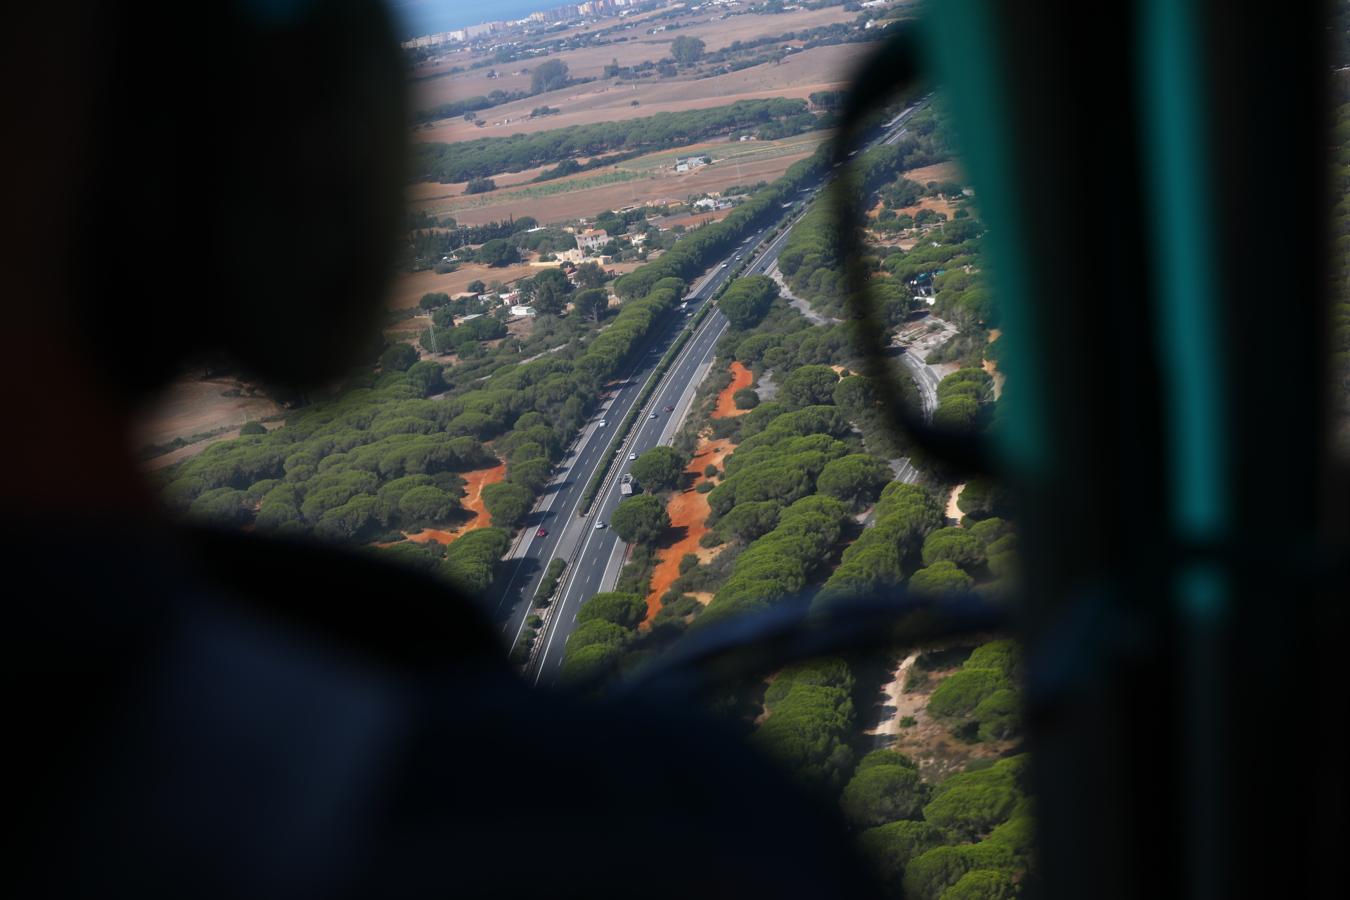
[643,362,755,627]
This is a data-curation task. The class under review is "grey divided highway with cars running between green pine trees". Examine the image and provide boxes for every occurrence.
[510,101,922,687]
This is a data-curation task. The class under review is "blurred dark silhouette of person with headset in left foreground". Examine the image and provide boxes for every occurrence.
[3,0,885,897]
